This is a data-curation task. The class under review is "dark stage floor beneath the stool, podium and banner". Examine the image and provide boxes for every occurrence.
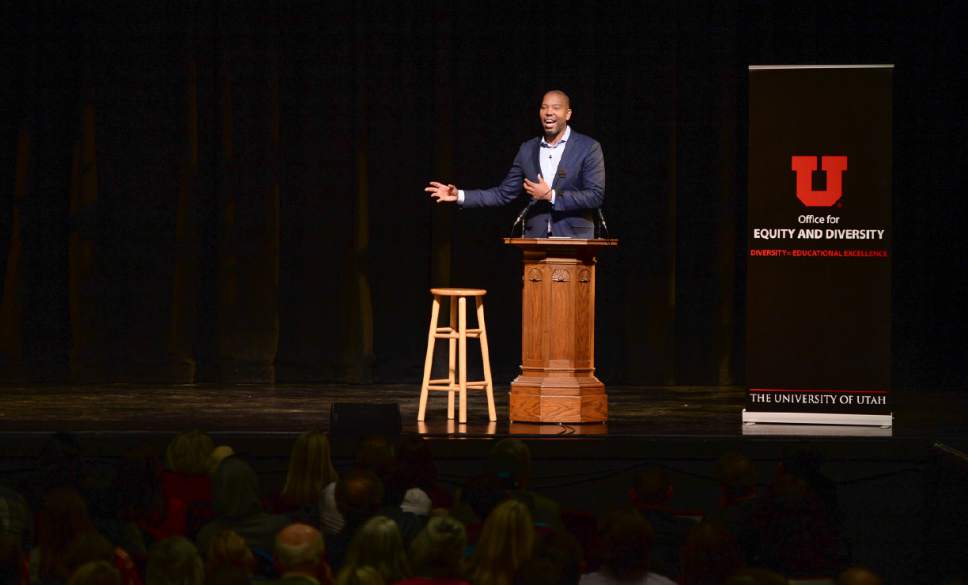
[0,384,968,448]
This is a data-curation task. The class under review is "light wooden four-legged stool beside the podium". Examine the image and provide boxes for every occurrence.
[417,288,497,423]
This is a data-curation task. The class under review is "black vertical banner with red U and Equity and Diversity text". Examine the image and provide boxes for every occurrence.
[743,65,893,426]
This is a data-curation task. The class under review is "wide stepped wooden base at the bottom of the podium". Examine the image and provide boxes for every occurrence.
[509,376,608,423]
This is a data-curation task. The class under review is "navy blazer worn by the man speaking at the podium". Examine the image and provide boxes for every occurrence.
[462,130,605,238]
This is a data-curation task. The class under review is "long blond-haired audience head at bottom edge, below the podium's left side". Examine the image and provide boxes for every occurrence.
[470,500,535,585]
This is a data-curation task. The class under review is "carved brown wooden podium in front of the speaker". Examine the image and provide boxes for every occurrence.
[504,238,618,423]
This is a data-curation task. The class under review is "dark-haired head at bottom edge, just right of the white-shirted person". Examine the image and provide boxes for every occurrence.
[679,522,743,585]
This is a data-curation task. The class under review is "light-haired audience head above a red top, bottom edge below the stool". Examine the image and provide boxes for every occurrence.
[410,516,467,579]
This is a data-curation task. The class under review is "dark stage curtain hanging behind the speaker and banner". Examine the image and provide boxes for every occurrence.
[0,0,968,386]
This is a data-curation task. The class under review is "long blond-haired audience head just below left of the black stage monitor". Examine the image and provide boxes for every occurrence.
[282,431,337,506]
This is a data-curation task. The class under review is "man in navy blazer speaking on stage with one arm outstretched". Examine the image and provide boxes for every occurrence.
[424,89,605,239]
